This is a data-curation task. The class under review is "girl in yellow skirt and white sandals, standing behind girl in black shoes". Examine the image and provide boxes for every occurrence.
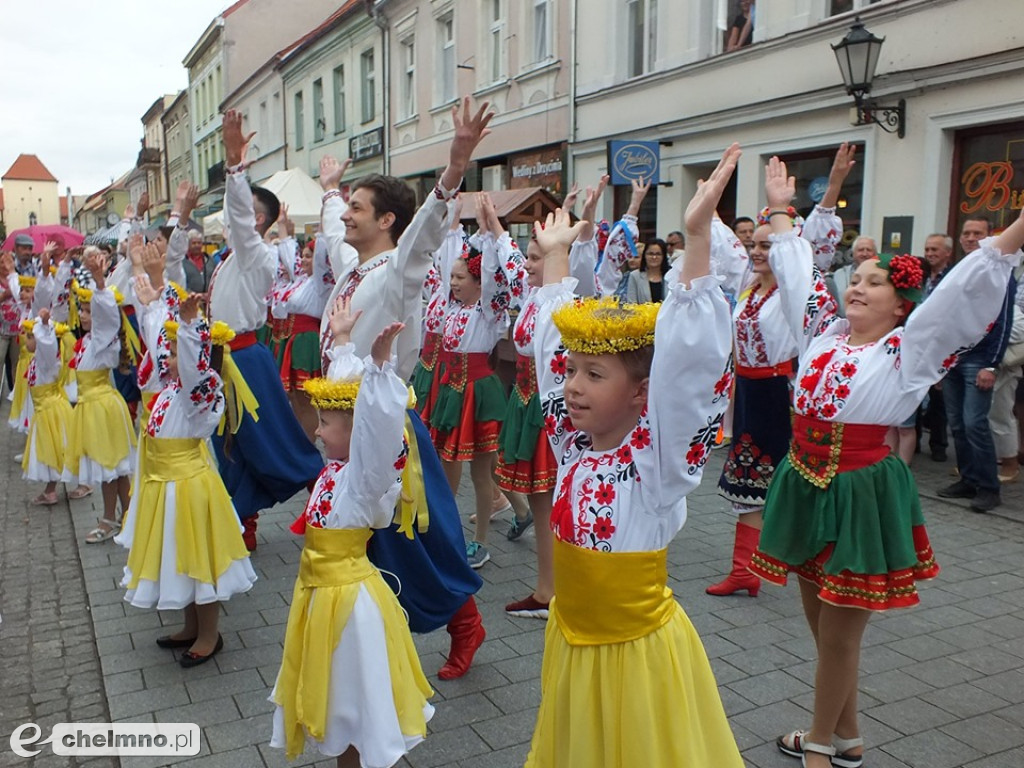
[68,249,135,544]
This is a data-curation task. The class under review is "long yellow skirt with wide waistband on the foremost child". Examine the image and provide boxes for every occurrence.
[526,541,743,768]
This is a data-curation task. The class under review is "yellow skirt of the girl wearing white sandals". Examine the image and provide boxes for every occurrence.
[68,370,135,474]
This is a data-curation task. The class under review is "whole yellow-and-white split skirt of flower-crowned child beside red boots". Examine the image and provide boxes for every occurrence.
[271,526,433,761]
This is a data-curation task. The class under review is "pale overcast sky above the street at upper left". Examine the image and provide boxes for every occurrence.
[0,0,231,195]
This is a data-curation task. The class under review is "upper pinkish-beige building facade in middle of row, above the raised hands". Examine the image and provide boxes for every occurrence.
[380,0,571,188]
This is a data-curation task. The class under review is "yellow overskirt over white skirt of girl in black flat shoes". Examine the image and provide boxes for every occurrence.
[121,437,243,589]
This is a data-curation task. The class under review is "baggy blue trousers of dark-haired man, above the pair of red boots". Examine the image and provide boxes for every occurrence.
[368,411,483,633]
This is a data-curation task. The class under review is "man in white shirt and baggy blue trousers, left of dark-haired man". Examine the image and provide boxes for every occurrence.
[209,110,324,551]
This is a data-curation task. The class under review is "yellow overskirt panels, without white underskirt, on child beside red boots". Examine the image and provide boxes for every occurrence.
[274,526,433,760]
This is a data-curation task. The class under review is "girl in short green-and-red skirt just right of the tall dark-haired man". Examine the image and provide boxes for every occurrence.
[430,193,523,568]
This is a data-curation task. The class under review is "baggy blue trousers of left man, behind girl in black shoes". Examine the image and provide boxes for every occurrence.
[213,344,324,520]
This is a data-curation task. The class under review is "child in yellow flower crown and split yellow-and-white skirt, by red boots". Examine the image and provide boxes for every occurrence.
[270,299,433,768]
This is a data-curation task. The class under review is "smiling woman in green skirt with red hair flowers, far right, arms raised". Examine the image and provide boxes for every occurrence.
[751,158,1024,768]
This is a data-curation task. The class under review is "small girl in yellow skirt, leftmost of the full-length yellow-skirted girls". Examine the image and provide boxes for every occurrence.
[22,309,74,507]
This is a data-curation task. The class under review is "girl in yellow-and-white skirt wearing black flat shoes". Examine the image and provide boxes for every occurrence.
[116,286,256,668]
